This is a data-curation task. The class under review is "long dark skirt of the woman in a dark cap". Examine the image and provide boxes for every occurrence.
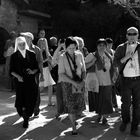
[96,86,113,115]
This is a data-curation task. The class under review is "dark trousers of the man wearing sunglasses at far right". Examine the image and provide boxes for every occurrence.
[121,78,140,131]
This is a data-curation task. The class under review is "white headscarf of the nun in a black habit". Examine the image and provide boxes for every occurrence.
[15,36,29,58]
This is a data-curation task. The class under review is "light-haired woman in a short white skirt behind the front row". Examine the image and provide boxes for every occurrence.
[38,38,55,106]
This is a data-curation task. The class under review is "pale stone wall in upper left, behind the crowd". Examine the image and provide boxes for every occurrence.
[0,0,38,33]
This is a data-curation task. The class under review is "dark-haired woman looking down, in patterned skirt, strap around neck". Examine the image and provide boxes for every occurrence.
[58,37,86,135]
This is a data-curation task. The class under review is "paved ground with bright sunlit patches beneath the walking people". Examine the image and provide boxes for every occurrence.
[0,91,139,140]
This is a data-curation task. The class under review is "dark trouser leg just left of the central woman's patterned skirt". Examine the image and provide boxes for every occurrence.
[56,82,64,114]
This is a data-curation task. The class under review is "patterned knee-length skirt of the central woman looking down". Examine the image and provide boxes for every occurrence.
[62,82,85,114]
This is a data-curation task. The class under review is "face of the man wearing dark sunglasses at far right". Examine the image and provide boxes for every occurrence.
[126,29,139,43]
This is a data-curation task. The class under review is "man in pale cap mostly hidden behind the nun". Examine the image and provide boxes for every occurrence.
[20,32,44,116]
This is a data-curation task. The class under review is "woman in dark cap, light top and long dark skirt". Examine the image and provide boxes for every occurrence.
[89,38,113,124]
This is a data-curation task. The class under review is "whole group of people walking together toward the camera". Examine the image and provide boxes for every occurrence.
[3,27,140,136]
